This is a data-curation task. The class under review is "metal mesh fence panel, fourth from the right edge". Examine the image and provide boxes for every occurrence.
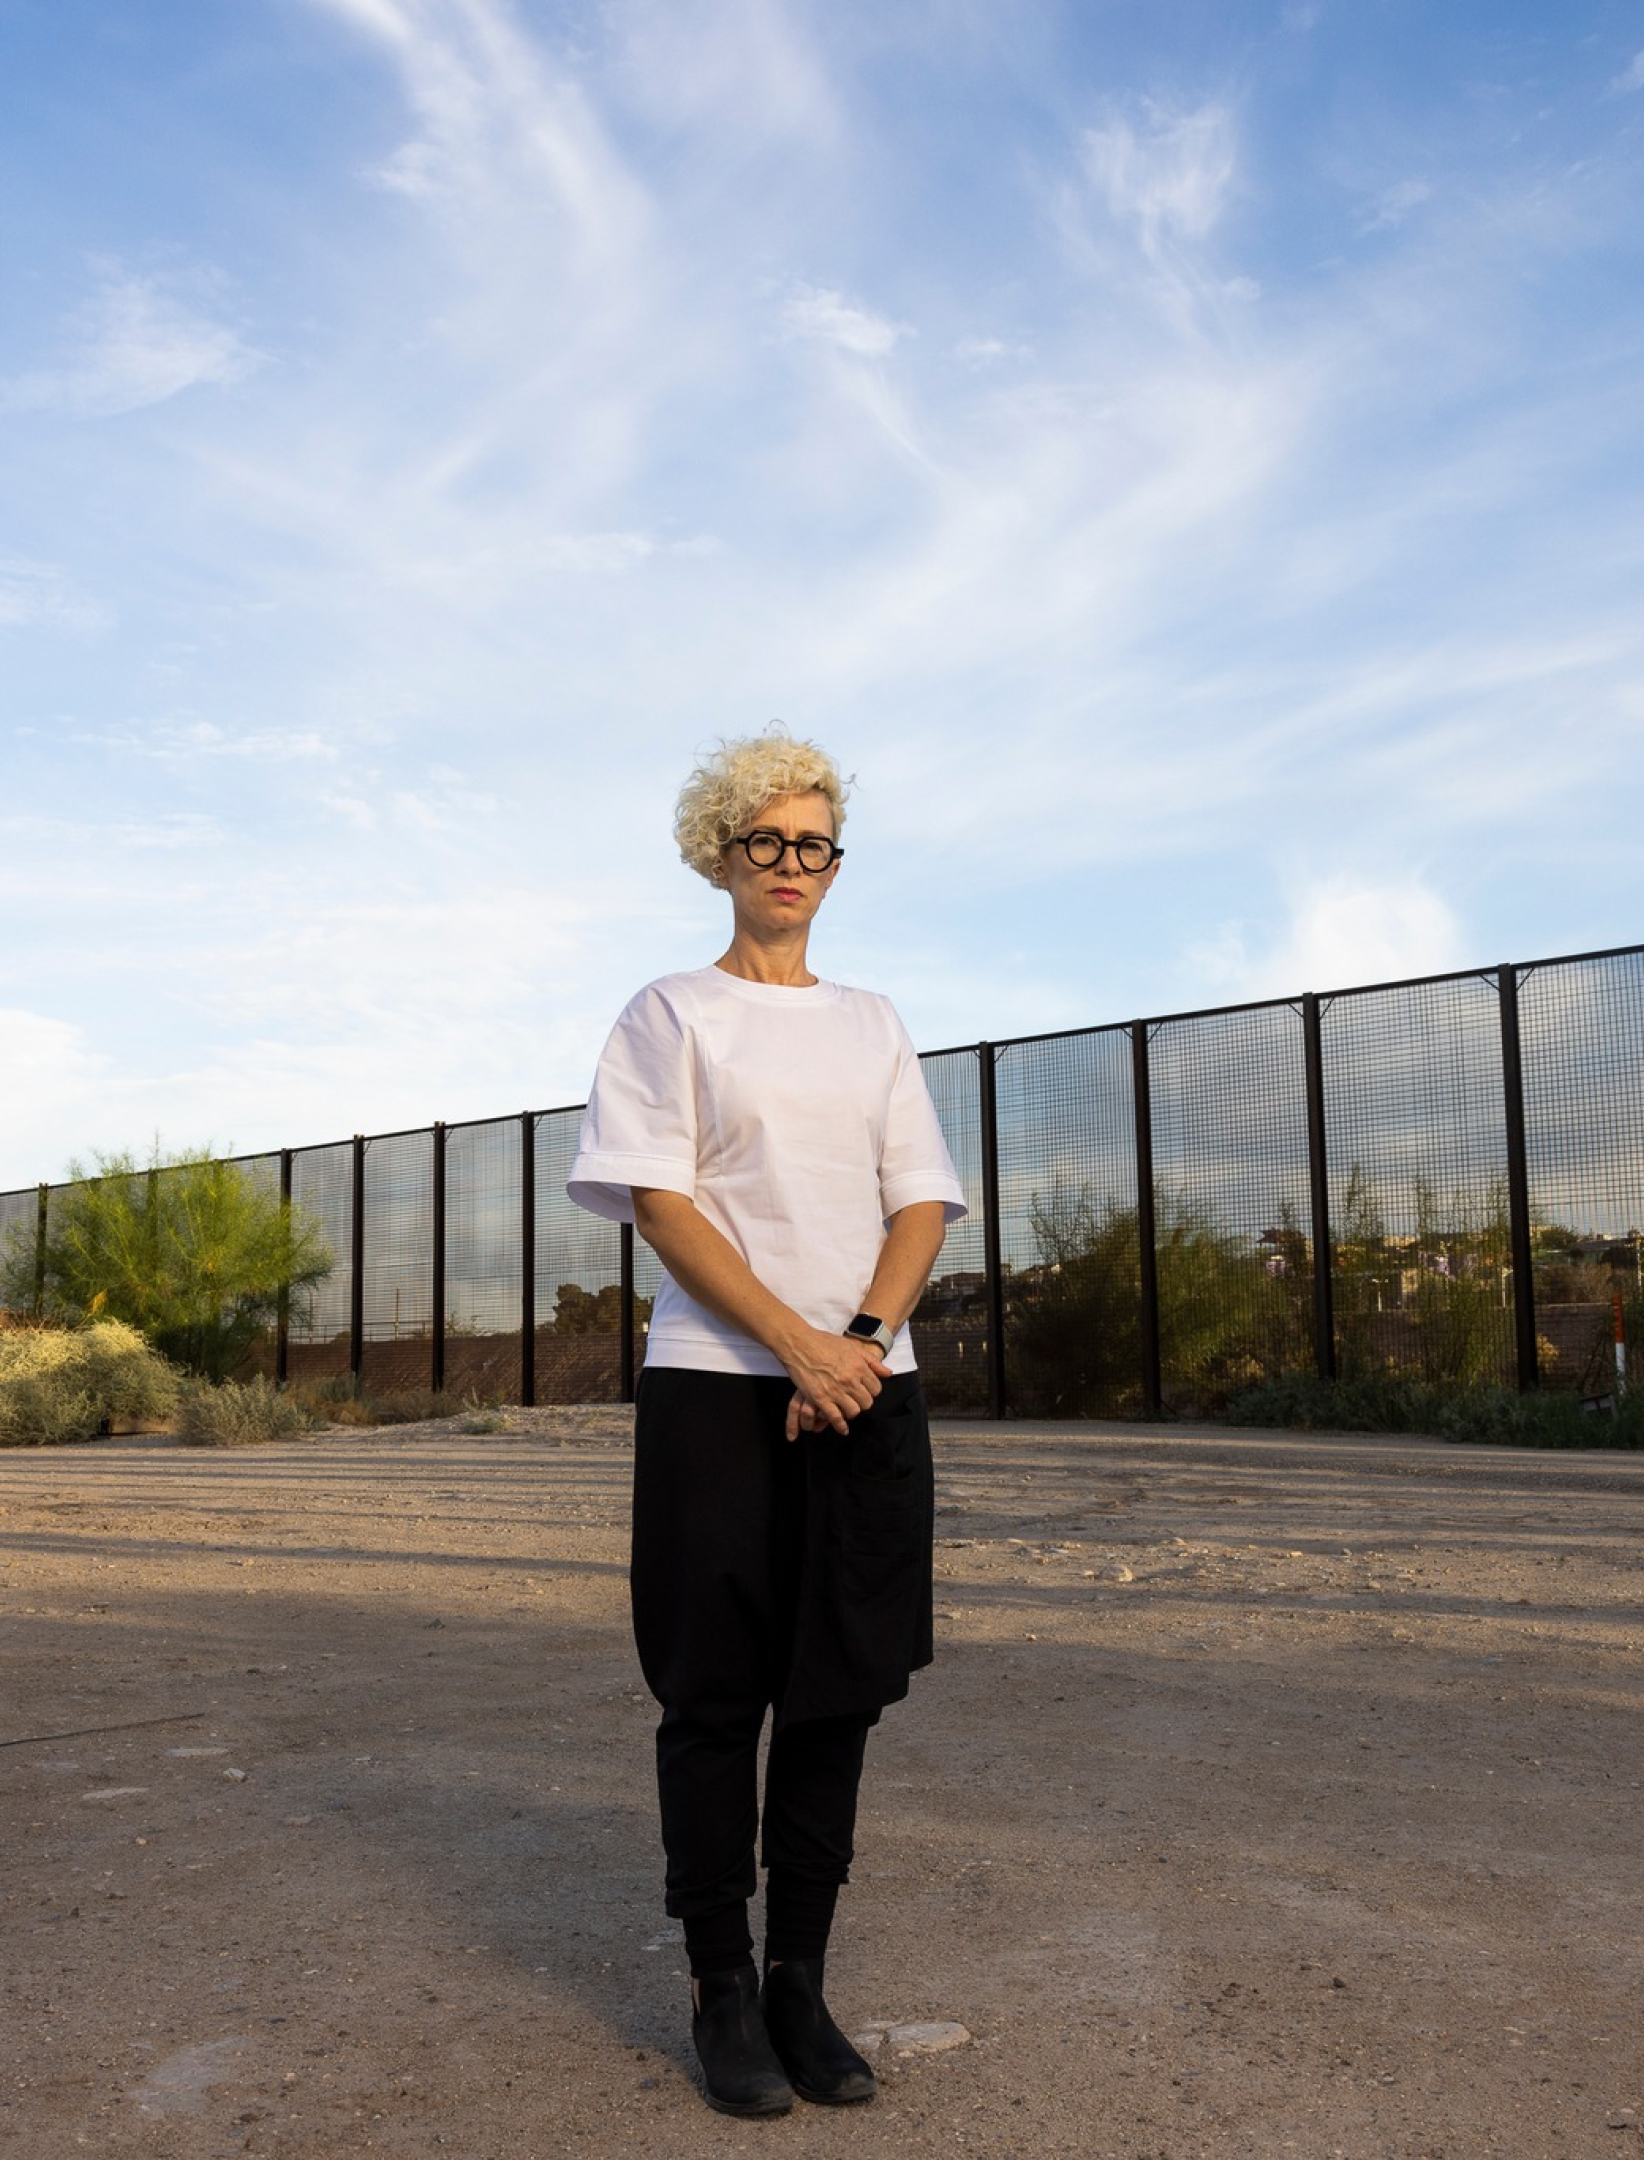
[994,1028,1141,1417]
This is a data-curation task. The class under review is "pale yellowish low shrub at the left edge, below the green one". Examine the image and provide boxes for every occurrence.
[0,1320,179,1447]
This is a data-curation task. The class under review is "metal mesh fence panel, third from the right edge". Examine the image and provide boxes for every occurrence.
[1147,1004,1313,1415]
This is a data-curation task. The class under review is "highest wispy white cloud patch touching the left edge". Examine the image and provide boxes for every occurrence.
[0,270,261,419]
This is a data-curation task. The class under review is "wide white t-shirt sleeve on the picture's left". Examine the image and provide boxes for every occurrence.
[566,983,696,1223]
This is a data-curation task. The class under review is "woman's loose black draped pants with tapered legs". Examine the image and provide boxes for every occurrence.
[631,1367,931,1922]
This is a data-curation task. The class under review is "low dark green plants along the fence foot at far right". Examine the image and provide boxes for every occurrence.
[1223,1372,1644,1447]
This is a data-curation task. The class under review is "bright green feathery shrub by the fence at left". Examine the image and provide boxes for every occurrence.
[0,1151,331,1380]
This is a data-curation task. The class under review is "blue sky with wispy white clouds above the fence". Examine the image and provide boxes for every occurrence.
[0,0,1644,1186]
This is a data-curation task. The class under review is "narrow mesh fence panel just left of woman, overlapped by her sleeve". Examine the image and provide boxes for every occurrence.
[536,1110,626,1402]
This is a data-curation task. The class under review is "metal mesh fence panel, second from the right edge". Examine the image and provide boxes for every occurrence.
[1320,974,1514,1385]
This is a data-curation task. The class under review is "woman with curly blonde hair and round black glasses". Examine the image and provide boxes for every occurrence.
[568,728,964,2115]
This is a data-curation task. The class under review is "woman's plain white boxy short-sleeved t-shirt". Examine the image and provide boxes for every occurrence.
[566,968,966,1374]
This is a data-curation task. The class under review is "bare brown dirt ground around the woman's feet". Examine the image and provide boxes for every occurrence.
[0,1410,1644,2160]
